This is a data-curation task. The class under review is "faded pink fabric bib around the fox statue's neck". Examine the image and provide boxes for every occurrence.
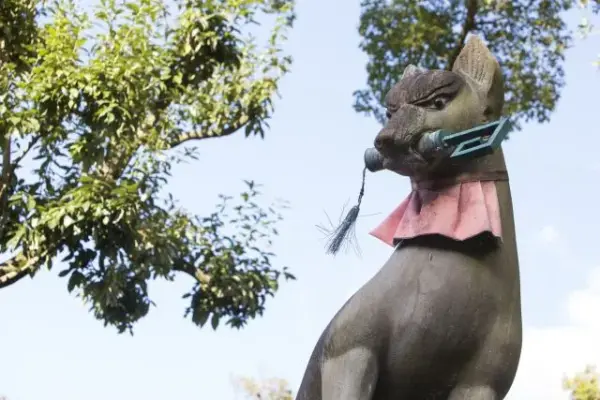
[370,181,502,246]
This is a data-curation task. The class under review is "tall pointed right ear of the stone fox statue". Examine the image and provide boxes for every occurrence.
[452,35,504,117]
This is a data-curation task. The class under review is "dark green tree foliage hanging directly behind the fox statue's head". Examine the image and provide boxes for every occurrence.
[354,0,574,126]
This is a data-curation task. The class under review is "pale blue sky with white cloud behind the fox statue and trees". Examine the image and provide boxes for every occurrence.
[0,0,600,400]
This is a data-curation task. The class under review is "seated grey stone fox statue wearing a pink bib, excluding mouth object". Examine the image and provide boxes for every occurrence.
[296,36,522,400]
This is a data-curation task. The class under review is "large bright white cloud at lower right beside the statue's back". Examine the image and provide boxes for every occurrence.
[507,268,600,400]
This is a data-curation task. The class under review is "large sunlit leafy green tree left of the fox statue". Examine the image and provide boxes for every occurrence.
[0,0,294,332]
